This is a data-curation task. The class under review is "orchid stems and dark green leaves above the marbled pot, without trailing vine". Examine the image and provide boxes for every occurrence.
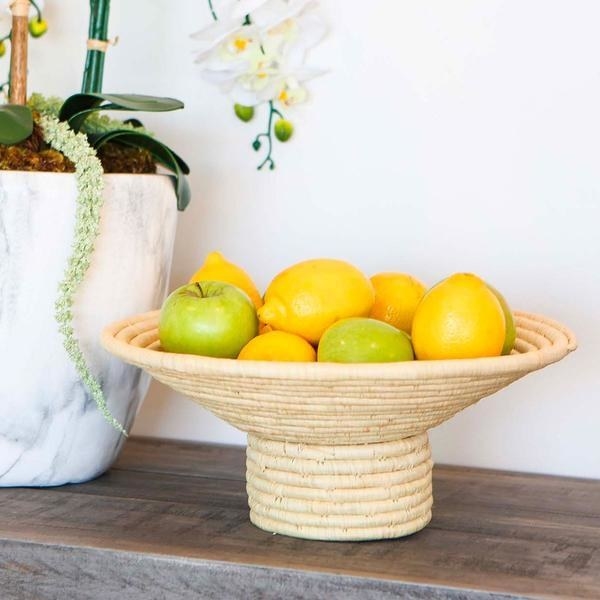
[0,0,190,210]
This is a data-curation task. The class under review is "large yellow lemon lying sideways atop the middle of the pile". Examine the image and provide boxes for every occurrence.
[258,258,374,344]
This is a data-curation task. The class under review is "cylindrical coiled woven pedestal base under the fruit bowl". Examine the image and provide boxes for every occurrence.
[246,433,433,541]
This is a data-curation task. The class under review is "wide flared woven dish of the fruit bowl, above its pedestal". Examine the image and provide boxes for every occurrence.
[103,311,575,445]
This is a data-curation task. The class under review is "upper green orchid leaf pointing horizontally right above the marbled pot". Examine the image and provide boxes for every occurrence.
[58,93,183,131]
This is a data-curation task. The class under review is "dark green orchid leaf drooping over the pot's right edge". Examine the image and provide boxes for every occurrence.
[89,129,192,210]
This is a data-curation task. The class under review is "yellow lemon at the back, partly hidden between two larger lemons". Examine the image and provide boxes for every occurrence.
[369,273,427,333]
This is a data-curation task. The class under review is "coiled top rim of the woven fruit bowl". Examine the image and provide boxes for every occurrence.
[101,310,577,382]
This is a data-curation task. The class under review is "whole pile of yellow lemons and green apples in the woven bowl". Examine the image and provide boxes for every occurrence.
[159,252,516,363]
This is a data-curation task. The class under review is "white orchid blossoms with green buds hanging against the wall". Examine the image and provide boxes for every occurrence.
[192,0,327,170]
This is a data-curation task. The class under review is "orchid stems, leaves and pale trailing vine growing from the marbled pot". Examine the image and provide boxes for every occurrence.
[0,0,190,435]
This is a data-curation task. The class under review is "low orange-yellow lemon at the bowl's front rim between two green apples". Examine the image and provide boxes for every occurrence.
[238,331,317,362]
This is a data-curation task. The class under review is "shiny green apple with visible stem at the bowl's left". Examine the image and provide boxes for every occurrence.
[158,281,258,358]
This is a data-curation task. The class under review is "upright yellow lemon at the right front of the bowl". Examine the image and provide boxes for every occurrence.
[412,273,506,360]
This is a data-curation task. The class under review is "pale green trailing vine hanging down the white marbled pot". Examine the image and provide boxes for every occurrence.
[40,115,127,436]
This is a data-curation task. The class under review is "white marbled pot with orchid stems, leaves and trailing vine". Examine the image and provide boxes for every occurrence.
[0,0,190,486]
